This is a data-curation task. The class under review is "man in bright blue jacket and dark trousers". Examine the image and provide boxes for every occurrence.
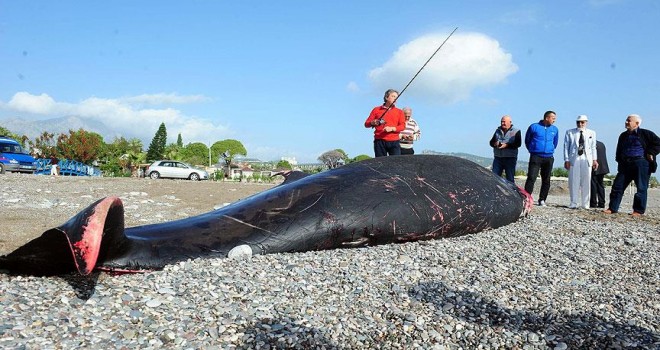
[525,111,559,206]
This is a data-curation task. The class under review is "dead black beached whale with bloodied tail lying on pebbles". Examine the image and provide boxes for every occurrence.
[0,155,532,275]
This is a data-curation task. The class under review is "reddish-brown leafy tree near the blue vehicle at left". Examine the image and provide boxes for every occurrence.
[57,129,105,164]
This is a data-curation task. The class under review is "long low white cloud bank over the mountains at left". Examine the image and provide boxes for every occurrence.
[4,92,232,143]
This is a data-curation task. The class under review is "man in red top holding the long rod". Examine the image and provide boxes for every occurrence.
[364,89,406,157]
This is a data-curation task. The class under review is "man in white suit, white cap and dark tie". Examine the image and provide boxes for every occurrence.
[564,114,598,209]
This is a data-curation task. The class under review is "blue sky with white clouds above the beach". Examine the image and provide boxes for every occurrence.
[0,0,660,167]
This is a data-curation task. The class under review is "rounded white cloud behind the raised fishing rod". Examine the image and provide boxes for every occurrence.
[369,33,518,104]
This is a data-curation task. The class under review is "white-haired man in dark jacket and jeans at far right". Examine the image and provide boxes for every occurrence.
[605,114,660,217]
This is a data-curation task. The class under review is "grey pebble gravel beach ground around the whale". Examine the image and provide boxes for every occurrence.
[0,174,660,349]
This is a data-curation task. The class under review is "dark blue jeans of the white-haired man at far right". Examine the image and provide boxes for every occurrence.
[609,157,651,214]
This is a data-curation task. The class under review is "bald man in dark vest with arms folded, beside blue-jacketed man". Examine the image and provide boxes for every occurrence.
[490,115,522,182]
